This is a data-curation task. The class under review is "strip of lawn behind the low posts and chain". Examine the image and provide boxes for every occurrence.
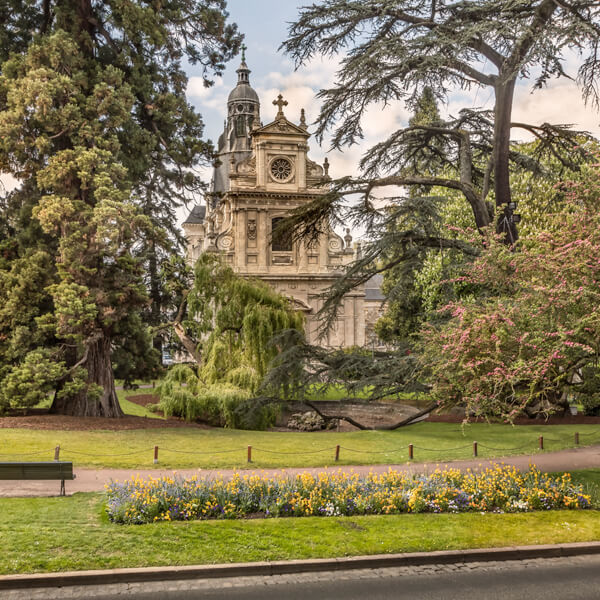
[0,422,600,469]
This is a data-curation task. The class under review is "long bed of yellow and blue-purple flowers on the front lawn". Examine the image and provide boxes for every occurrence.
[107,466,591,523]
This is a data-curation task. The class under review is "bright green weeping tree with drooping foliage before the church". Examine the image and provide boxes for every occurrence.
[158,253,304,428]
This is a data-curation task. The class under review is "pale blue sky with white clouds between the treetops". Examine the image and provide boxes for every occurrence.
[182,0,600,229]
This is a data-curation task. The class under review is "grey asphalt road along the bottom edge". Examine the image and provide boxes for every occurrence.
[7,555,600,600]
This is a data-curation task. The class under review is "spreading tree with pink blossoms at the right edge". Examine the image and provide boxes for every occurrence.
[424,165,600,421]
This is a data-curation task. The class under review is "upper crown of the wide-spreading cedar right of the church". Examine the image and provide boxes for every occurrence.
[282,0,600,248]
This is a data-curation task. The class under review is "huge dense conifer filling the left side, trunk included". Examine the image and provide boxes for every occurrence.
[0,0,241,416]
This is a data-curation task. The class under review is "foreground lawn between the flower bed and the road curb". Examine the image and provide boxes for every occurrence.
[0,469,600,574]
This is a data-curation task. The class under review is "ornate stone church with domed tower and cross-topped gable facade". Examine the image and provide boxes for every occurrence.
[183,56,380,348]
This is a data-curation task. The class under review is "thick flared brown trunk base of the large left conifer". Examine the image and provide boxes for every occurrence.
[50,337,123,418]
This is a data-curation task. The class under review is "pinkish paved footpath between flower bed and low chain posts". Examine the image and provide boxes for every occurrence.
[0,446,600,497]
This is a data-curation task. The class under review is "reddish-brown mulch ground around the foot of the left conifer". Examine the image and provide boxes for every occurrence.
[0,394,212,431]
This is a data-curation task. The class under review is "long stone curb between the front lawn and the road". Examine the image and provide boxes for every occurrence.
[0,542,600,590]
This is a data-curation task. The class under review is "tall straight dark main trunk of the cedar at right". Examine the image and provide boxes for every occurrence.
[493,79,519,245]
